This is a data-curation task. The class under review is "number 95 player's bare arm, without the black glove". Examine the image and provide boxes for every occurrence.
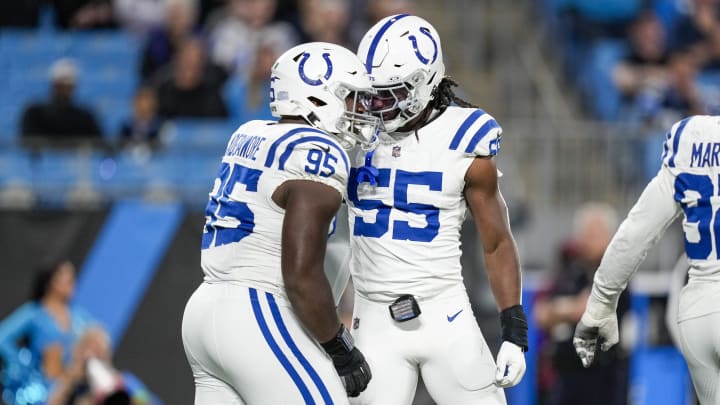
[273,180,342,342]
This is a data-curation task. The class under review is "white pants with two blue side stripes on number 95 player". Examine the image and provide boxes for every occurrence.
[182,283,348,405]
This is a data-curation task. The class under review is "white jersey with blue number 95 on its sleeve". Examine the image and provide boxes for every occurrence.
[201,121,350,297]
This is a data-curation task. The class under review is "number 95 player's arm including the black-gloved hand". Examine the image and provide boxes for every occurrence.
[273,180,372,397]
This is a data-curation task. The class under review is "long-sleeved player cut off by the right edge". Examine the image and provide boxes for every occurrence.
[573,116,720,405]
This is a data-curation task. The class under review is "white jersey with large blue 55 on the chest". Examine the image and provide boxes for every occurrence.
[348,107,501,300]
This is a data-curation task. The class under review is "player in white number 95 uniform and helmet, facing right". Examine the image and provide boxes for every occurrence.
[182,43,378,405]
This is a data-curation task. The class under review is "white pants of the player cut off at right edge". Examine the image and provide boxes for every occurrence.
[676,312,720,405]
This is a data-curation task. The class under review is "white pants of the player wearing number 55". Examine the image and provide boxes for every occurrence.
[350,289,506,405]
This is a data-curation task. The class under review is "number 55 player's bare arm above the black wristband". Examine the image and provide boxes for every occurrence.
[465,158,521,311]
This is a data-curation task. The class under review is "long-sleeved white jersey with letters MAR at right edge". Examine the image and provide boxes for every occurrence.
[595,116,720,321]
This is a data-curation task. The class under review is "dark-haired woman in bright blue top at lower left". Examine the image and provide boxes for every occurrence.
[0,261,94,398]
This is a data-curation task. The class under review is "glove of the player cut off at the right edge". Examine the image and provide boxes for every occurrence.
[573,291,620,367]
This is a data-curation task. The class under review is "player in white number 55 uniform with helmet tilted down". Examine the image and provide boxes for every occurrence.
[348,14,527,405]
